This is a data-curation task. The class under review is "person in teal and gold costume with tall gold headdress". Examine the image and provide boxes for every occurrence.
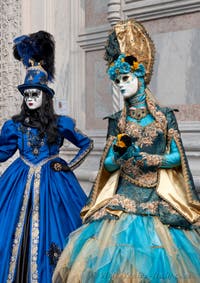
[53,20,200,283]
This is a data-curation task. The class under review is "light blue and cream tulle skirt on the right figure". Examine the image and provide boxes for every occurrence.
[53,214,200,283]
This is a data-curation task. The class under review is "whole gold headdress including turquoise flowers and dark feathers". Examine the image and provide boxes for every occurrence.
[105,19,155,84]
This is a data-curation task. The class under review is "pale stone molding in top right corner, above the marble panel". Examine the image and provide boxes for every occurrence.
[123,0,200,21]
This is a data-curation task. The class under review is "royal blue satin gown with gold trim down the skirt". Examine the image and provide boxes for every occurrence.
[0,116,92,283]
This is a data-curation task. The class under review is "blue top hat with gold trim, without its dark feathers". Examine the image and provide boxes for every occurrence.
[18,63,55,97]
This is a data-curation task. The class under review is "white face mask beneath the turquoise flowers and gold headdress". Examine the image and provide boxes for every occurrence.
[114,73,138,98]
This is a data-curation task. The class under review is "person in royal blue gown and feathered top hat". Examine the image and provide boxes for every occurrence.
[0,31,92,283]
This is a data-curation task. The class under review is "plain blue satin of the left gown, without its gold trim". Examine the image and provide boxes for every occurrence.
[0,116,91,283]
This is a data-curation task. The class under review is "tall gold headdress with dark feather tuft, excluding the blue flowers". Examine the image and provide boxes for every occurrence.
[105,19,155,84]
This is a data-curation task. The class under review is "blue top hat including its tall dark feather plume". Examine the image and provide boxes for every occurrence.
[13,31,55,96]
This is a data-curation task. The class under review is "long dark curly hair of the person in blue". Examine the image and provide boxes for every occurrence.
[12,92,59,145]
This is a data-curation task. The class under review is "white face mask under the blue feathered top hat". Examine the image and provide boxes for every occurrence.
[24,88,42,110]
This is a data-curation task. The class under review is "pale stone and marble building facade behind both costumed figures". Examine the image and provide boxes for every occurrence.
[0,0,200,195]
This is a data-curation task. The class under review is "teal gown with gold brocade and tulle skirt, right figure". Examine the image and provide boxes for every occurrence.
[53,104,200,283]
